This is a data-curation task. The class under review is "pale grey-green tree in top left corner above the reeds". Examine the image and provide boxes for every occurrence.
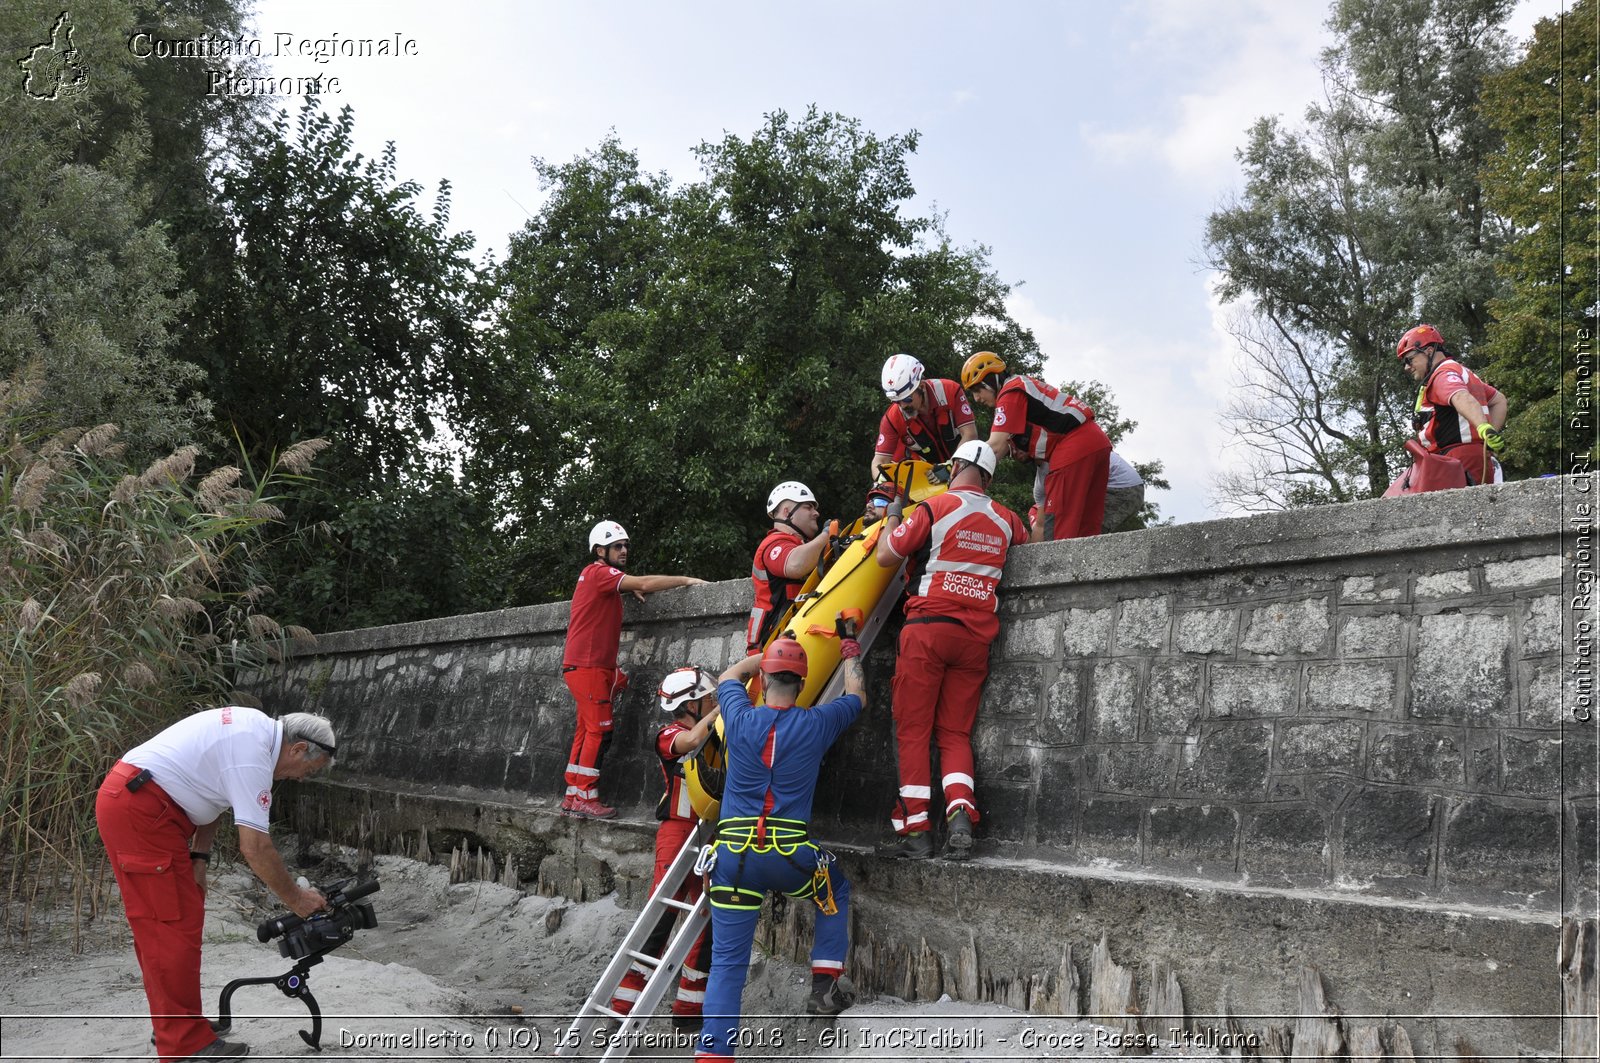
[0,0,216,455]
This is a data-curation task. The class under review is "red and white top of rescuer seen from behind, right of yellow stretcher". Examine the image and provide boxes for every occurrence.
[890,487,1027,640]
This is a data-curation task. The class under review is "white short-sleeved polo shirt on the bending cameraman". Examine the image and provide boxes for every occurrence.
[122,704,283,834]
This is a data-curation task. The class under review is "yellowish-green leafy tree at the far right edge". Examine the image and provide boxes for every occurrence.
[1480,0,1600,475]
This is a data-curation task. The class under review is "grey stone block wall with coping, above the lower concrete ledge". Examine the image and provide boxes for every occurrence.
[254,479,1595,911]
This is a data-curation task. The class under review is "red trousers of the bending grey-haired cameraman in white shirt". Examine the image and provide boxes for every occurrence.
[94,760,216,1060]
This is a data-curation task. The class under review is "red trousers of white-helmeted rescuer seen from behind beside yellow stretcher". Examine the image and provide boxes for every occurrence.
[890,616,989,834]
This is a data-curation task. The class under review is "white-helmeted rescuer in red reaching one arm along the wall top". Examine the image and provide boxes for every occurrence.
[562,520,706,820]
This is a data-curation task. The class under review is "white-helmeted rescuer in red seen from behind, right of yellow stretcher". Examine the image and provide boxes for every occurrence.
[877,440,1027,860]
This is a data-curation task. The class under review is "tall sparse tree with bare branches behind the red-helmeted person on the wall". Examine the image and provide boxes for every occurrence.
[1206,0,1510,509]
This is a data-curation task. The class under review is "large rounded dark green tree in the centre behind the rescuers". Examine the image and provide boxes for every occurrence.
[467,109,1038,602]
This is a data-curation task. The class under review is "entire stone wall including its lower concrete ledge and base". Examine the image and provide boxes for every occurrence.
[250,480,1597,1057]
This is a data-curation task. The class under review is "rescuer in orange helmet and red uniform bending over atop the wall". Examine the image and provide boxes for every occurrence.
[962,351,1110,543]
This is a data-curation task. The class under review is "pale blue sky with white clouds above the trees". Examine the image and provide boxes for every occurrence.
[256,0,1563,522]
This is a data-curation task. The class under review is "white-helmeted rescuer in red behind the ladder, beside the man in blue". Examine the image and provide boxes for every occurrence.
[611,668,718,1029]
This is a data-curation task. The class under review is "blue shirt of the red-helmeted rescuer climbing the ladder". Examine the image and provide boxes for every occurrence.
[717,679,861,823]
